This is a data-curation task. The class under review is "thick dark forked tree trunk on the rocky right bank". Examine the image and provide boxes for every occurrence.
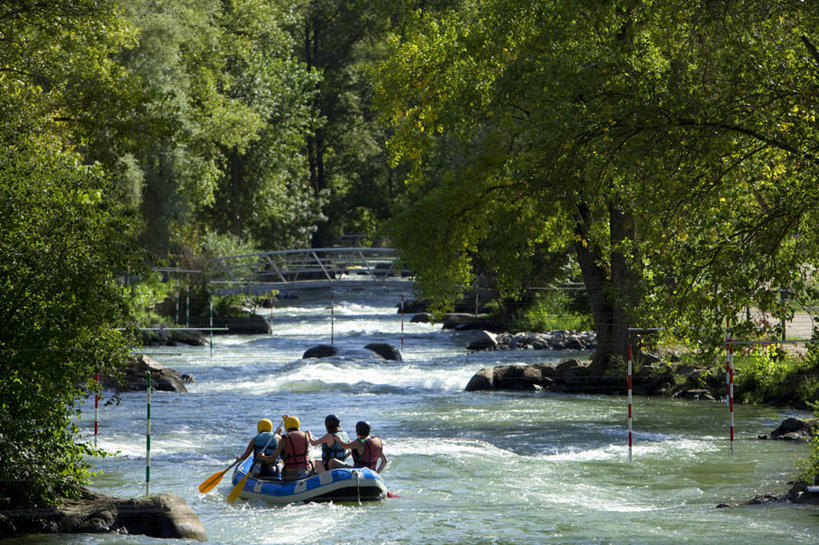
[575,203,640,372]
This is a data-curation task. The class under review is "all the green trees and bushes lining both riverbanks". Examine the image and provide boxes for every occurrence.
[0,0,819,532]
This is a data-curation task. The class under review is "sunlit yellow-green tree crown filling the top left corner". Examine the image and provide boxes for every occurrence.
[0,0,136,150]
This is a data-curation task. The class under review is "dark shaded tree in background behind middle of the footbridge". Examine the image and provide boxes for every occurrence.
[292,0,416,247]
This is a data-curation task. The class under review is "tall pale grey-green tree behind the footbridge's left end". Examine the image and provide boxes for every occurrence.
[122,0,316,257]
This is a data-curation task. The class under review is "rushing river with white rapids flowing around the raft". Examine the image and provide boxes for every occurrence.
[9,288,819,545]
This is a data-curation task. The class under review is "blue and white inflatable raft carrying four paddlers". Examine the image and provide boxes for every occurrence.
[227,456,387,505]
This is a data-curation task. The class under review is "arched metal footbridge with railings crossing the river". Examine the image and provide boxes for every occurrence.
[211,247,412,294]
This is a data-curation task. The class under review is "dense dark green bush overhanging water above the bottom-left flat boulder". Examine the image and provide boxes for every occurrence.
[0,139,141,507]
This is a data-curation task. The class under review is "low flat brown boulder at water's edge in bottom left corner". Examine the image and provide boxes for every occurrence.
[0,490,207,541]
